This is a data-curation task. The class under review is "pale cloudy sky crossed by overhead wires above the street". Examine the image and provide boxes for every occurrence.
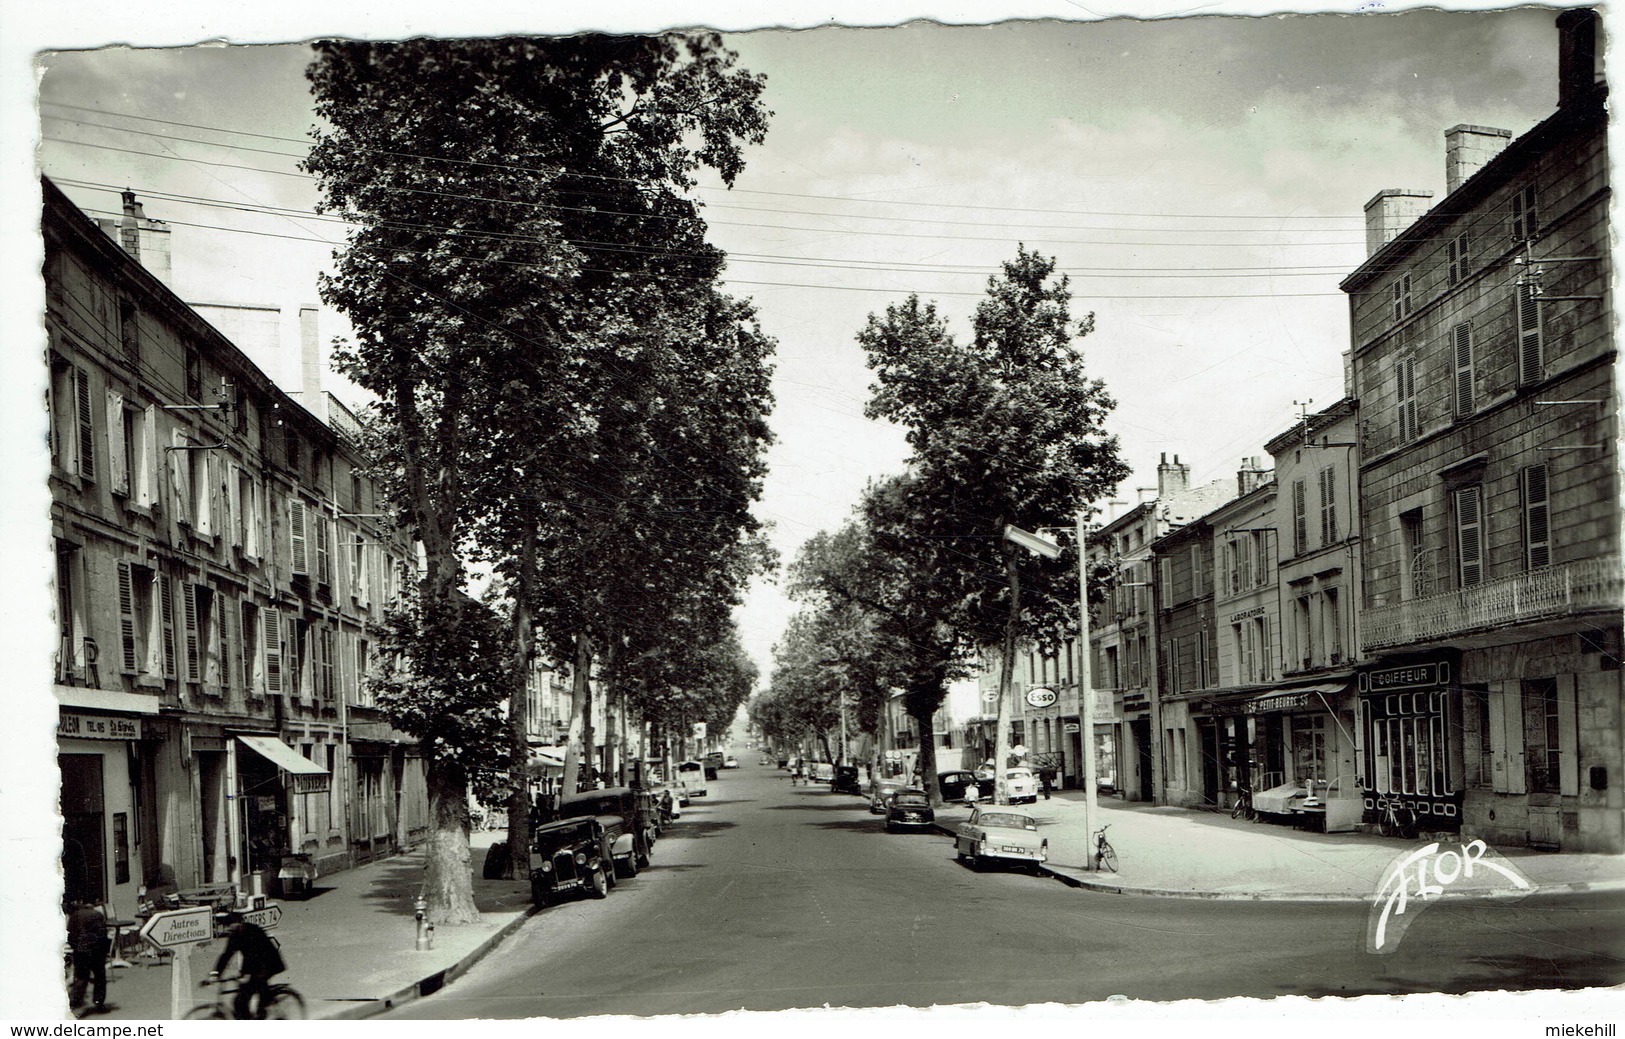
[0,0,1618,1027]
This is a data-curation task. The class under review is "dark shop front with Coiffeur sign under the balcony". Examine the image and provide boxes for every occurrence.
[1360,659,1463,833]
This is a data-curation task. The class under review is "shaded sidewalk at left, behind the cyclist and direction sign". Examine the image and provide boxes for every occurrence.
[85,829,530,1023]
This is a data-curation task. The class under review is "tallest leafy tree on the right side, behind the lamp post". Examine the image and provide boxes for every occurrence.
[858,247,1128,800]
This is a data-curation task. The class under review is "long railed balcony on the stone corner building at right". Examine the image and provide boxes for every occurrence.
[1360,554,1625,650]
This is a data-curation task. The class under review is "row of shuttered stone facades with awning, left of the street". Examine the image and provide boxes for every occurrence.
[42,180,427,911]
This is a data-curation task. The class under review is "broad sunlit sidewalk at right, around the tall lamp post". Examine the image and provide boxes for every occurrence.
[936,790,1625,901]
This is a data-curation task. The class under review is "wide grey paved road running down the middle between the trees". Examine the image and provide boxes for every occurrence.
[390,758,1625,1018]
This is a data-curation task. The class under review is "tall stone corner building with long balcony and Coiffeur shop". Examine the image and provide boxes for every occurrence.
[1344,10,1625,852]
